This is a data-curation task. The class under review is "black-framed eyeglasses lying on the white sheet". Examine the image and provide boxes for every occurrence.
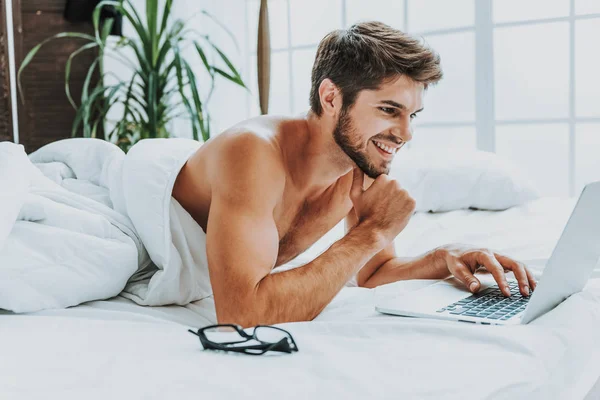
[188,324,298,356]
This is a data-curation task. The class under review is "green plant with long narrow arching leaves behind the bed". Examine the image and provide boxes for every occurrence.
[18,0,247,151]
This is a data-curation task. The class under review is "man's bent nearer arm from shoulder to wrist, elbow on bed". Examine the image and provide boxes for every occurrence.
[206,134,386,327]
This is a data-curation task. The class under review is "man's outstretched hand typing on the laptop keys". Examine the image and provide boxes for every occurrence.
[436,244,537,296]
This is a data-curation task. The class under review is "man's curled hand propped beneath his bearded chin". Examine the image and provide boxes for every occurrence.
[350,168,415,245]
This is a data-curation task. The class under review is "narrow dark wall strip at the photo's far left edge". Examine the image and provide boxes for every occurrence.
[0,0,12,141]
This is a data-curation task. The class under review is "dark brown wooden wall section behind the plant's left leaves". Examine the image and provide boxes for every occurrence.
[12,0,98,153]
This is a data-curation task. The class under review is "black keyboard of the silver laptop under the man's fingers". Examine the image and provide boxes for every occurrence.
[437,282,531,321]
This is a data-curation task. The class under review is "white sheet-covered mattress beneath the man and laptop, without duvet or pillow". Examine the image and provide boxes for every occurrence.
[0,198,600,399]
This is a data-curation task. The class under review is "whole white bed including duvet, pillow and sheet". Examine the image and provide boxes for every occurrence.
[0,139,600,399]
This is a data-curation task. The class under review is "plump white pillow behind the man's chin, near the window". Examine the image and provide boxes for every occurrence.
[390,149,540,212]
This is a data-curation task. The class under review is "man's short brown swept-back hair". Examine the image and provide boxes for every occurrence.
[310,21,442,116]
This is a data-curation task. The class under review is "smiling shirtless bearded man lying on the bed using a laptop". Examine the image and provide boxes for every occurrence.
[173,22,536,327]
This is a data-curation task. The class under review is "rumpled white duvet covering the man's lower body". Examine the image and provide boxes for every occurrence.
[0,139,212,312]
